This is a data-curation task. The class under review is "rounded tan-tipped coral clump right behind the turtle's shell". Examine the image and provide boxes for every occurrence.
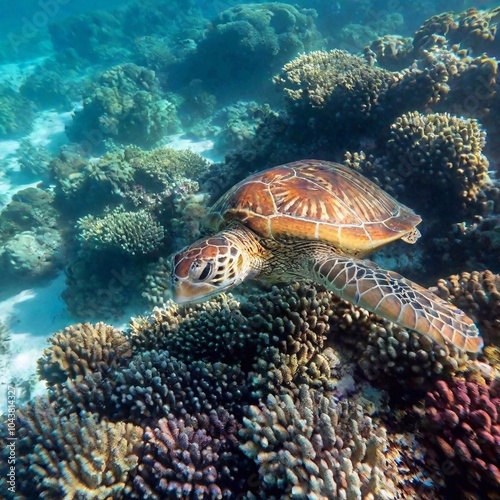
[347,112,490,220]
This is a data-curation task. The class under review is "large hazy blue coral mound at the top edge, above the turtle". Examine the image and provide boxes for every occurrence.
[174,2,320,102]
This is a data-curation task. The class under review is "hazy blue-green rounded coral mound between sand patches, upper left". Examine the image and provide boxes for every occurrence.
[66,63,178,148]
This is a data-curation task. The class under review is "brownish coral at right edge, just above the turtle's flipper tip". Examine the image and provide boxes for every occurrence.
[433,271,500,343]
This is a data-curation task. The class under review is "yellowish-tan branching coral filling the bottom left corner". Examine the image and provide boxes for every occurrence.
[0,399,143,500]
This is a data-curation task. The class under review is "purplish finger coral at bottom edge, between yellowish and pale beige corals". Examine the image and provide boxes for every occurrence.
[132,410,254,498]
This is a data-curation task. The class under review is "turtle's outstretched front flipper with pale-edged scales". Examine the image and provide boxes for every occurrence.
[313,255,483,352]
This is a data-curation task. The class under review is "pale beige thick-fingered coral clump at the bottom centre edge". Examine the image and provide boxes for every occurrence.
[240,385,396,499]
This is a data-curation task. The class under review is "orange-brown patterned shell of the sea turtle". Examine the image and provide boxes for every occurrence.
[205,160,421,256]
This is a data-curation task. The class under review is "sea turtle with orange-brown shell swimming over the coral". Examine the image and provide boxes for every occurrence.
[172,160,483,352]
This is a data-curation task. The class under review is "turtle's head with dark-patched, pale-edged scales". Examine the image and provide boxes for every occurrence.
[172,231,256,304]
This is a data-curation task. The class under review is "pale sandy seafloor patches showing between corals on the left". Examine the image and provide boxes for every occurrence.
[0,61,218,413]
